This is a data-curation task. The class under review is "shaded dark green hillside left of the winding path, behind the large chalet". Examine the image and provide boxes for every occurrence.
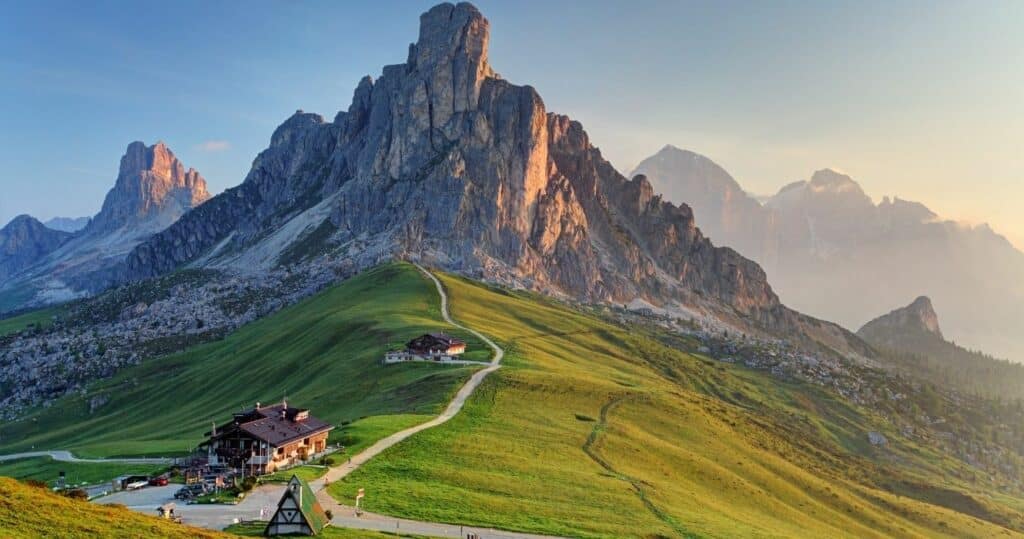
[0,265,487,456]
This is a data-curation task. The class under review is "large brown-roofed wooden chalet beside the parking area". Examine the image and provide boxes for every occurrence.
[200,401,334,475]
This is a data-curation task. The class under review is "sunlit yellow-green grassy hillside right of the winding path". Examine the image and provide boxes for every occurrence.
[331,277,1021,537]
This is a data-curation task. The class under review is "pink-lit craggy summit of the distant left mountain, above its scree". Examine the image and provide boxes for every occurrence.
[86,140,210,234]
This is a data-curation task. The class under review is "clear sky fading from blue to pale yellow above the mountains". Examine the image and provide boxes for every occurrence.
[0,0,1024,247]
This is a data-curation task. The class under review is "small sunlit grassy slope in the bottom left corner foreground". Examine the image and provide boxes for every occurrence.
[0,478,234,539]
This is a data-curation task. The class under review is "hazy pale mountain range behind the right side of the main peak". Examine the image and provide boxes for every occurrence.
[633,147,1024,360]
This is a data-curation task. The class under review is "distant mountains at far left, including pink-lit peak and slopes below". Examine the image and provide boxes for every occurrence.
[0,141,210,312]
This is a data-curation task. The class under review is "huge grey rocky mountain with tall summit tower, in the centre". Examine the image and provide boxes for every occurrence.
[126,3,855,358]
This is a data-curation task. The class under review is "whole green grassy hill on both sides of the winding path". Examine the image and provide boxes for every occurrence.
[0,264,1024,538]
